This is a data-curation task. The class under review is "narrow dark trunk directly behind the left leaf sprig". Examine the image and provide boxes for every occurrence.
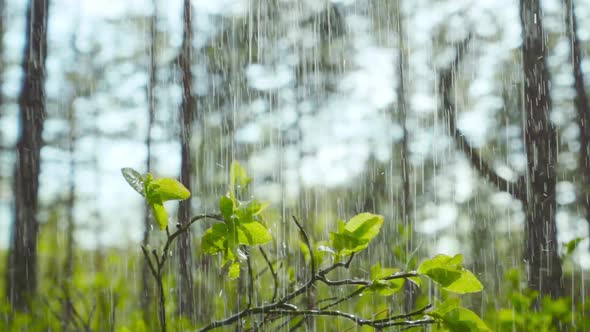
[178,0,196,318]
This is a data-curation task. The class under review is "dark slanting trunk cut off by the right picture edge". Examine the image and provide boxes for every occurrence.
[564,0,590,252]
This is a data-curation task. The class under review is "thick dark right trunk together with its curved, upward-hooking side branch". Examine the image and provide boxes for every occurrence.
[438,26,563,297]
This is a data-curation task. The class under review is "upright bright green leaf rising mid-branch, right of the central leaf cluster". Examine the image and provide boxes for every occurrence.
[330,213,383,256]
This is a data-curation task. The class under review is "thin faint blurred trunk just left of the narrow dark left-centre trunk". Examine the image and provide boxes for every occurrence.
[140,0,158,322]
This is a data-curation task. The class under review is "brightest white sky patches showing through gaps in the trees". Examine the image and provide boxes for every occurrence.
[0,0,590,265]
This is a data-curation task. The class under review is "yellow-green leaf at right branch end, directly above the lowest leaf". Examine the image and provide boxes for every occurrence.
[418,255,483,294]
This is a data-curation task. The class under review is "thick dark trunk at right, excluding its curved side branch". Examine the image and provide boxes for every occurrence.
[520,0,563,297]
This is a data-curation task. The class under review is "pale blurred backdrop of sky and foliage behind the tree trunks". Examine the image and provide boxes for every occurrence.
[0,0,590,280]
